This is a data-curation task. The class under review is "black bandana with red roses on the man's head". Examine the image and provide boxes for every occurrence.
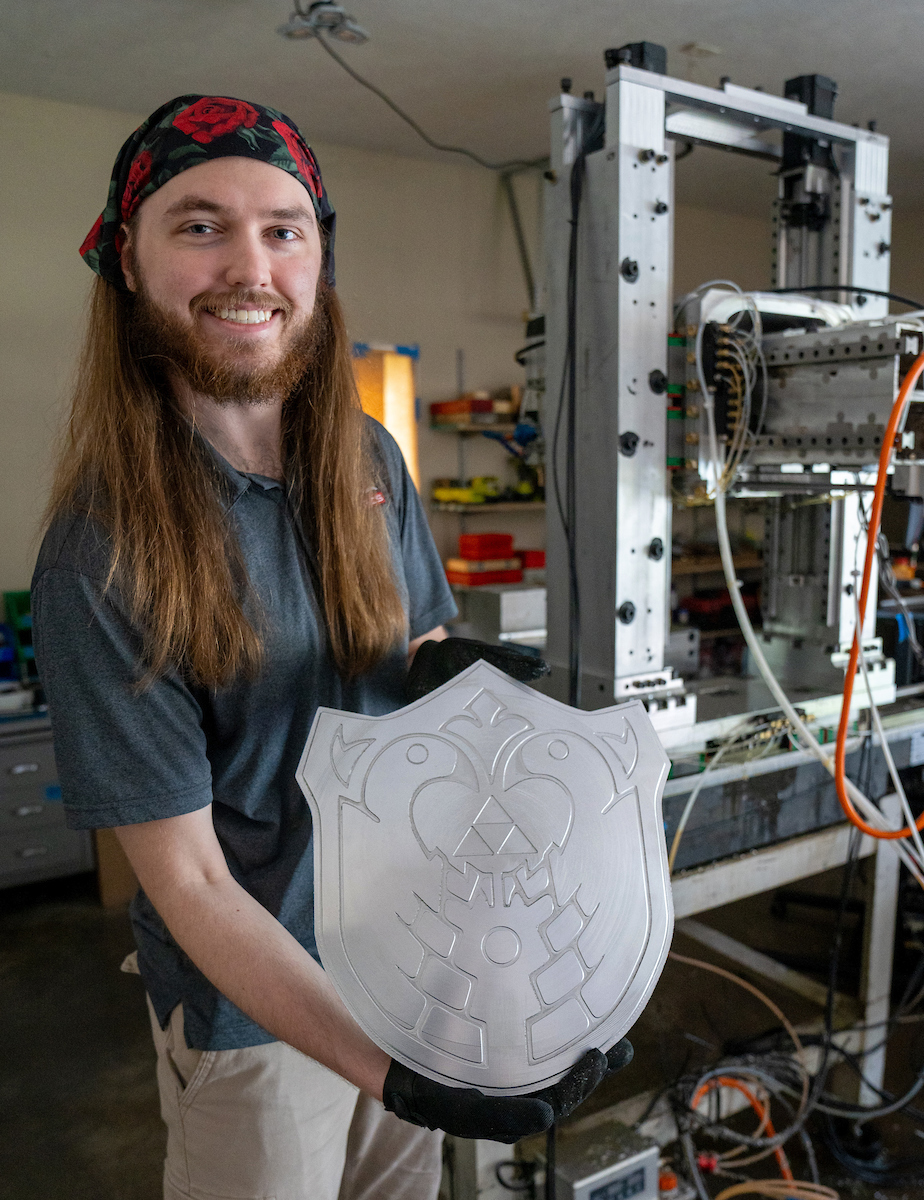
[80,96,336,290]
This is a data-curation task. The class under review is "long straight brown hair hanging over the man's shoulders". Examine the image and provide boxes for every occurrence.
[47,280,407,688]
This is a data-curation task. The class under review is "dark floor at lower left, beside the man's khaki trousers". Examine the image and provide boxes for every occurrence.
[0,876,166,1200]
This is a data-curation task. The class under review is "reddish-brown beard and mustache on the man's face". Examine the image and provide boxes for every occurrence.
[131,281,329,407]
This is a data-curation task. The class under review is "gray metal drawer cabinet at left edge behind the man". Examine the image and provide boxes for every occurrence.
[0,718,94,888]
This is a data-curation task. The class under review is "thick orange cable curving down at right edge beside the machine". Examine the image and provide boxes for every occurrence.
[834,353,924,840]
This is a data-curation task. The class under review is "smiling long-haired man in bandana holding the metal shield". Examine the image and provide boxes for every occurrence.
[34,96,607,1200]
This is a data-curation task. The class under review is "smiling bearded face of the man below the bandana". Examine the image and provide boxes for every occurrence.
[122,158,322,403]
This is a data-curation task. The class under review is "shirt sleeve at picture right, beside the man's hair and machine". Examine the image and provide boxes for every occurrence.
[376,425,458,642]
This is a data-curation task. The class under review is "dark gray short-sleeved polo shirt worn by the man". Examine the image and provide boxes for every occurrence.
[32,422,456,1050]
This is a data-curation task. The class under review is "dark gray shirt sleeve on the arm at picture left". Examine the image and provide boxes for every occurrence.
[32,566,211,829]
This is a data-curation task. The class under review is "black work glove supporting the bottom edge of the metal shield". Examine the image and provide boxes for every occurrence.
[383,1038,632,1144]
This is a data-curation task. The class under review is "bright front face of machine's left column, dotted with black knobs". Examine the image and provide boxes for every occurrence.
[600,79,673,698]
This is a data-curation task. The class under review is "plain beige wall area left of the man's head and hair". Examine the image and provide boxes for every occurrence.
[0,95,138,590]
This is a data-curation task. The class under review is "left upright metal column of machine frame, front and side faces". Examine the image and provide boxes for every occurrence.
[545,75,673,708]
